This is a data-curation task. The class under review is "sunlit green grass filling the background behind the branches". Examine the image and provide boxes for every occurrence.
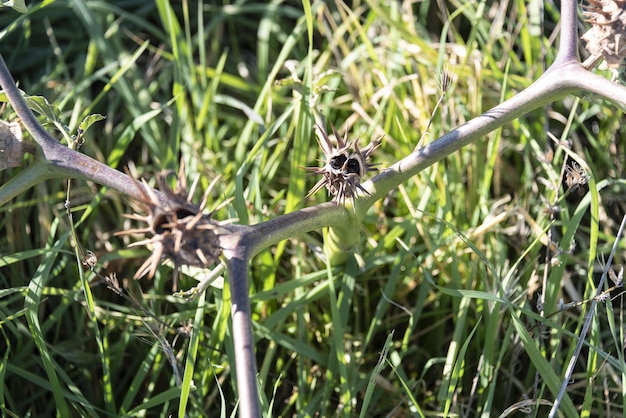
[0,0,626,417]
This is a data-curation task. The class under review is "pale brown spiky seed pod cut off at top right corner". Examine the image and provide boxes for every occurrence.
[582,0,626,69]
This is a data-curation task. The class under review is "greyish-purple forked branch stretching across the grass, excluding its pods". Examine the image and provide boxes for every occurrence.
[0,0,626,417]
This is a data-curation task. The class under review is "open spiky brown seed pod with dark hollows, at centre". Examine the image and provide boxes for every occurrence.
[305,124,381,204]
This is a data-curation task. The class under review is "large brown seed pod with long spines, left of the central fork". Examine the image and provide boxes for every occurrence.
[117,164,232,291]
